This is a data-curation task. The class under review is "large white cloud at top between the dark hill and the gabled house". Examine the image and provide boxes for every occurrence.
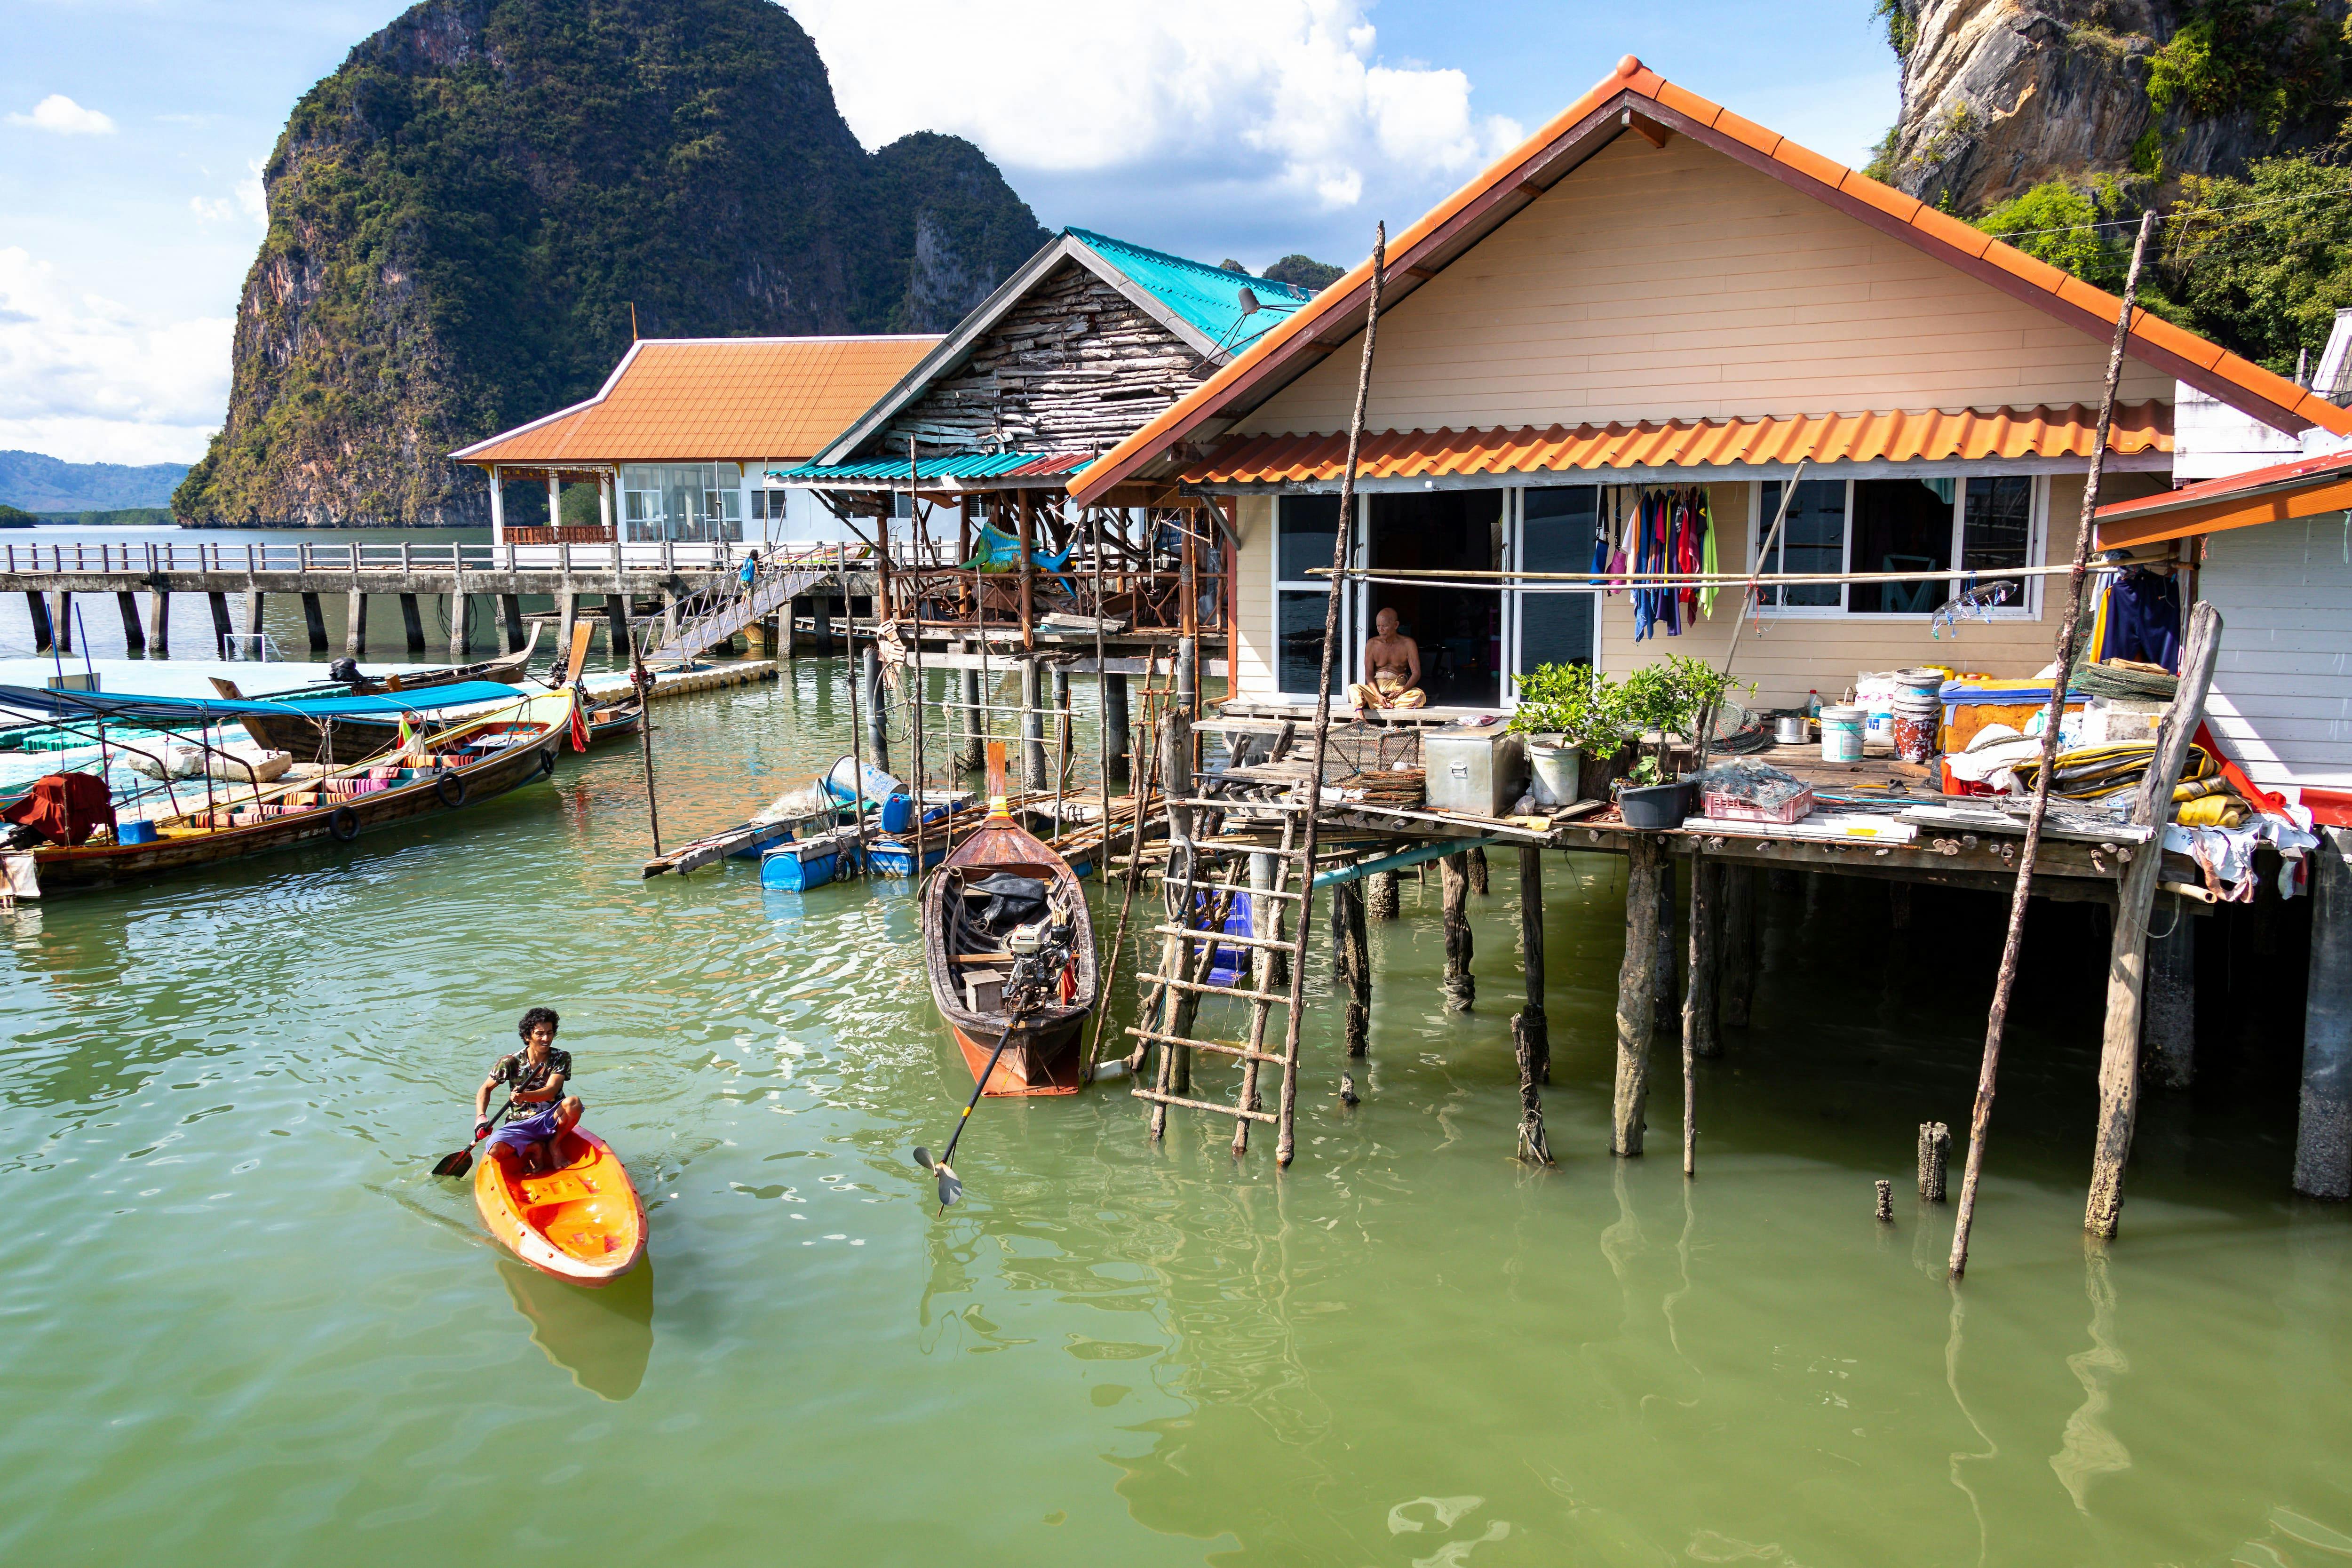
[790,0,1519,212]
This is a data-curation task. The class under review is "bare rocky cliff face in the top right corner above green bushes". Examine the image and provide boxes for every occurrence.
[1882,0,2345,216]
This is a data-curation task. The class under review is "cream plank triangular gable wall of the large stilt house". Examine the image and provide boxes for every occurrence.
[1237,136,2173,432]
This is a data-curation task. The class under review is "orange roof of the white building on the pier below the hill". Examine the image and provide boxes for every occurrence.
[452,336,938,465]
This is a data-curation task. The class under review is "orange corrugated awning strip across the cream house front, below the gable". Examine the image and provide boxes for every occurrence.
[1181,399,2173,484]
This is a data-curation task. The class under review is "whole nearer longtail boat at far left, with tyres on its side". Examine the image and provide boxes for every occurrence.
[26,691,576,896]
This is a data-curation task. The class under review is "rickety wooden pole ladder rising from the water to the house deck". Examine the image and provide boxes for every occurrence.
[1127,712,1315,1166]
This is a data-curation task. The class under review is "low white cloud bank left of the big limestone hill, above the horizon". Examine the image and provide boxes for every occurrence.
[0,247,235,463]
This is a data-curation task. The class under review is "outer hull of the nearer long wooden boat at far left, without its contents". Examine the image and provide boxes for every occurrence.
[33,691,572,896]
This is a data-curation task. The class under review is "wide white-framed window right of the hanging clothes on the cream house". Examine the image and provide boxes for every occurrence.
[1752,475,2042,616]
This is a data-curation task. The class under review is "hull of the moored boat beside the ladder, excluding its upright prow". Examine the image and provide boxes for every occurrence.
[922,816,1101,1096]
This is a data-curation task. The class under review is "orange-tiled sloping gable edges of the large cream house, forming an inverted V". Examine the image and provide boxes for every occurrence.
[1070,54,2352,503]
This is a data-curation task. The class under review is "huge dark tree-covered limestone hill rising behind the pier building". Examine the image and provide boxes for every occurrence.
[188,0,1047,526]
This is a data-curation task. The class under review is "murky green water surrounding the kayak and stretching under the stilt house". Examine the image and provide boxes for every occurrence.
[0,663,2352,1568]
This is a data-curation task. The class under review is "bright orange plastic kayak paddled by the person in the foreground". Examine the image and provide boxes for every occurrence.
[473,1126,644,1286]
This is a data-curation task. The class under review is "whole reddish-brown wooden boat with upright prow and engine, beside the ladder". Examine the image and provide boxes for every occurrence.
[922,740,1101,1096]
